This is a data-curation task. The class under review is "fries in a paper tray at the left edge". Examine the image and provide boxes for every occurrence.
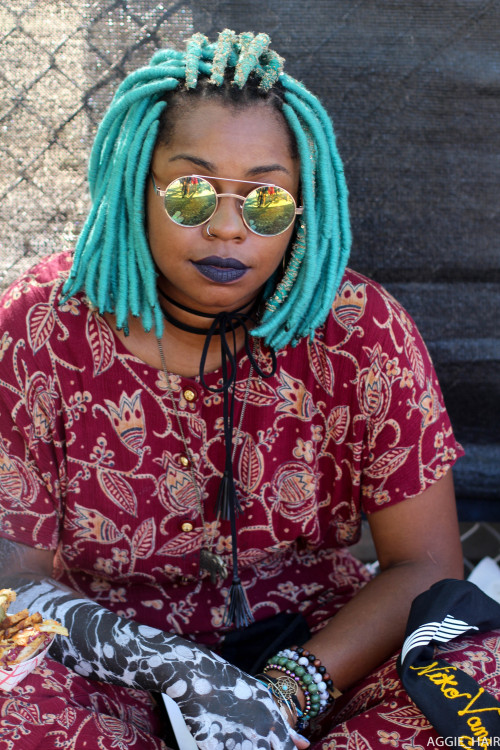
[0,589,68,669]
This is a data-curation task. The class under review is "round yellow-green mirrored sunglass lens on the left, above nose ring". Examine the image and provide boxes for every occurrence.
[164,177,217,227]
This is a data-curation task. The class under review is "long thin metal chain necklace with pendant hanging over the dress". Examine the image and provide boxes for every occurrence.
[156,338,253,583]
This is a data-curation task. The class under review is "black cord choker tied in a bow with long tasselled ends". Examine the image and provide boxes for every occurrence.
[158,288,276,627]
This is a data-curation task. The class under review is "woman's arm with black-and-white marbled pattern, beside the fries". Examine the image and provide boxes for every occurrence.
[0,539,296,750]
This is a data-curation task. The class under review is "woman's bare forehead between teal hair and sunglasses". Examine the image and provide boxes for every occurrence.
[155,101,298,176]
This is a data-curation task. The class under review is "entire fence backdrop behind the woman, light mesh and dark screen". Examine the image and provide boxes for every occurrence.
[0,0,500,520]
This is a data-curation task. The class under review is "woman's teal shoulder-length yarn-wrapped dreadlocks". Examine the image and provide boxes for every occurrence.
[64,29,351,349]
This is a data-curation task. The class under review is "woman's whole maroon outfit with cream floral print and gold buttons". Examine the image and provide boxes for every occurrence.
[0,254,500,750]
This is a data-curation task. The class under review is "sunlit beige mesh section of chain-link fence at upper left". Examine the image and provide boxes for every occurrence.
[0,0,201,285]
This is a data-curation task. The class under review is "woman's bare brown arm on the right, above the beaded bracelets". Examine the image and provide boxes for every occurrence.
[272,470,463,690]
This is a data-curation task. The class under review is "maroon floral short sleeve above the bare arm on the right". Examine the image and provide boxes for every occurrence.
[357,282,463,513]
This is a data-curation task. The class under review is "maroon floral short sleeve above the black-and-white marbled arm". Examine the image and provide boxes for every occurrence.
[0,262,64,549]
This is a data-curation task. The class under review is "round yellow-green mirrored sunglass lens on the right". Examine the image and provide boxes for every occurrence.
[243,185,295,236]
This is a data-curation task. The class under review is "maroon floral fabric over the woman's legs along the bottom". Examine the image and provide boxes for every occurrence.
[0,632,500,750]
